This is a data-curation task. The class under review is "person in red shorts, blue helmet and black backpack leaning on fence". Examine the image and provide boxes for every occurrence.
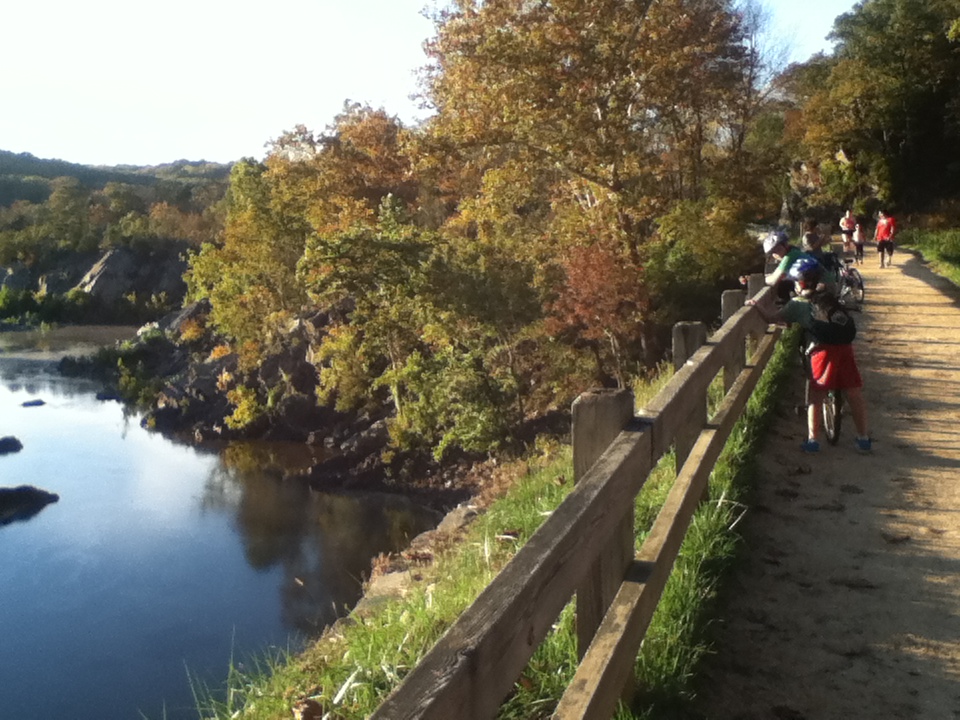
[747,258,872,452]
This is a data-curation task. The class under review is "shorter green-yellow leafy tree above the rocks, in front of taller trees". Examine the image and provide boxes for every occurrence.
[301,196,518,455]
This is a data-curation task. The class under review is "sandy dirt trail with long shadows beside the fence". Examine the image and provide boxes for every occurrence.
[697,252,960,720]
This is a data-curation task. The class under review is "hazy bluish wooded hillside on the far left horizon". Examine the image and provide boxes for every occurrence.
[0,150,231,206]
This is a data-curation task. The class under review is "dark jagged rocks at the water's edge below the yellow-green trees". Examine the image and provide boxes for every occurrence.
[114,301,404,487]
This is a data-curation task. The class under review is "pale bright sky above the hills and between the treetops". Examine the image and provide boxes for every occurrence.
[0,0,854,165]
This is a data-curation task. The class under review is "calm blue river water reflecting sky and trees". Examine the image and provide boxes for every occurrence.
[0,328,436,720]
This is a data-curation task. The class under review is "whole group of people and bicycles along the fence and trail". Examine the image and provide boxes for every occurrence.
[742,211,896,453]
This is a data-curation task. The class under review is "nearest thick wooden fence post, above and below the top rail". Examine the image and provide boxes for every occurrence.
[571,390,634,658]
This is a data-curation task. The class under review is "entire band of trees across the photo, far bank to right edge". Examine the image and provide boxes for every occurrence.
[22,0,960,456]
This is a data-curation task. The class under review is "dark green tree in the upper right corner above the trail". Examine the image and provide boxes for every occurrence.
[802,0,960,204]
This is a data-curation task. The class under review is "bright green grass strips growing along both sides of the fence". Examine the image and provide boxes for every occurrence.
[196,336,794,720]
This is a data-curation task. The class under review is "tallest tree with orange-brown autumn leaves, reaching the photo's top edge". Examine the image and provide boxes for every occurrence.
[426,0,753,375]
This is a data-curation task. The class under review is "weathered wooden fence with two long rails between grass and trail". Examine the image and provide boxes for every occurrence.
[371,276,779,720]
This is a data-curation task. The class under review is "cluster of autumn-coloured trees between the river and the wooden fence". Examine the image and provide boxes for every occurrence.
[190,0,770,462]
